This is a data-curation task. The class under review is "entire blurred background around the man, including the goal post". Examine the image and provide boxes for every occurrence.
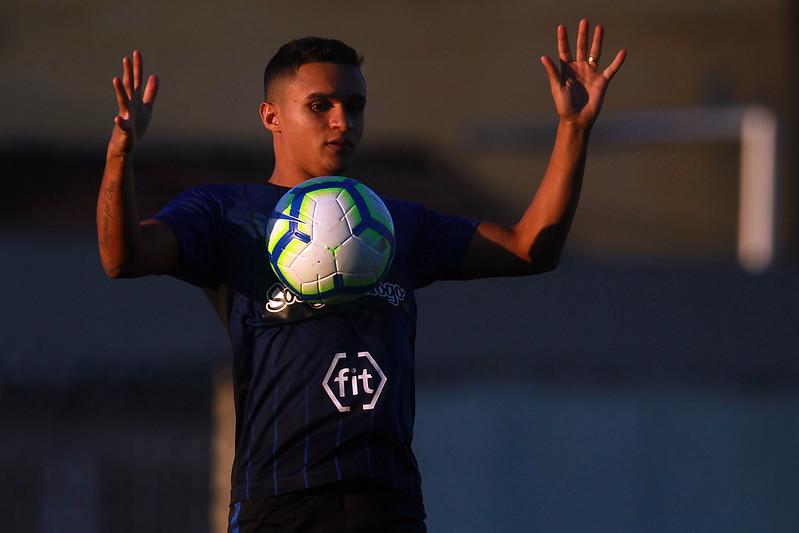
[0,0,799,533]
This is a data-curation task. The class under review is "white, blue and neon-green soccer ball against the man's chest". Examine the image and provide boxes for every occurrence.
[266,176,394,304]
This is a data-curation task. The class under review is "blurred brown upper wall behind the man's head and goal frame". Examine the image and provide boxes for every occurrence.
[0,0,798,261]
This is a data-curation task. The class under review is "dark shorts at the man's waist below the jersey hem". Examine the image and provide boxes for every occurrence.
[228,479,427,533]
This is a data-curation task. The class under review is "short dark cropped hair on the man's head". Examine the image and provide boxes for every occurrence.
[264,37,363,101]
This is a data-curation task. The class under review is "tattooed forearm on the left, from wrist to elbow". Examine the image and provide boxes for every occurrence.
[97,149,142,277]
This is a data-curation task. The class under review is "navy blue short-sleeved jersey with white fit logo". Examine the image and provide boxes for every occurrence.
[155,184,477,502]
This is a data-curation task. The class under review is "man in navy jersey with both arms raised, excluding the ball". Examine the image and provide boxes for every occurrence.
[97,20,625,532]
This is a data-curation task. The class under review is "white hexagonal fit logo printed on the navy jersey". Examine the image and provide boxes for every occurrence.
[322,352,388,413]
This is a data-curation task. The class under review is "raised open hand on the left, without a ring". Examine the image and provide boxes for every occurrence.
[108,50,158,156]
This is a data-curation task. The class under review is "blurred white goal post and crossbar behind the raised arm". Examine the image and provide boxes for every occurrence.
[466,105,777,274]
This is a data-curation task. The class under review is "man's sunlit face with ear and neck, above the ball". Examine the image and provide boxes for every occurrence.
[261,63,366,186]
